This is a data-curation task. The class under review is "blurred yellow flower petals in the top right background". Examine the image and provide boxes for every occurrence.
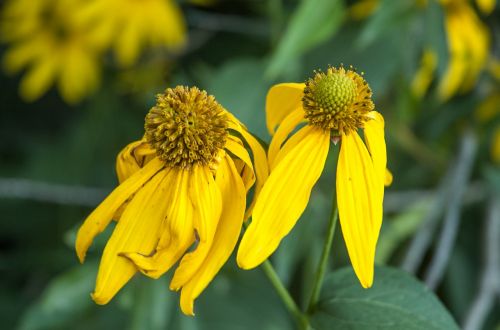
[438,0,490,101]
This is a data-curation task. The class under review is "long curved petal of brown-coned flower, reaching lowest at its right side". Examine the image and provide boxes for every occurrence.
[181,155,246,315]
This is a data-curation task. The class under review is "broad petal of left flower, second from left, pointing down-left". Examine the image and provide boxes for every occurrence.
[92,169,171,304]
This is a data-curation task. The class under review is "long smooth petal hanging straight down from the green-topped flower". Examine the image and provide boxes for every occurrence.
[336,132,382,288]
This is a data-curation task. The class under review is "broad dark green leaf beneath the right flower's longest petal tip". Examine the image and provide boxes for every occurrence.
[311,267,458,330]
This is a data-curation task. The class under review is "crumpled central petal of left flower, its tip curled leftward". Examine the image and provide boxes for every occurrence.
[123,169,195,278]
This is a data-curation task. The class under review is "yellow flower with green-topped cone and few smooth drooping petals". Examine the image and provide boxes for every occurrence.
[237,67,390,287]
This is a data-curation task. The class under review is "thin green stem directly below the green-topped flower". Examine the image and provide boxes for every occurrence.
[307,205,339,313]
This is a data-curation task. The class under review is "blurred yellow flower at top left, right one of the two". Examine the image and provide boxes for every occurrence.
[78,0,186,66]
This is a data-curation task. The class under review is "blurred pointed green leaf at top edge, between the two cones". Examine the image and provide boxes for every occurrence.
[266,0,344,79]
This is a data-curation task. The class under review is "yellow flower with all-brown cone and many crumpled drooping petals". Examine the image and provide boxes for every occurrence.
[76,86,267,315]
